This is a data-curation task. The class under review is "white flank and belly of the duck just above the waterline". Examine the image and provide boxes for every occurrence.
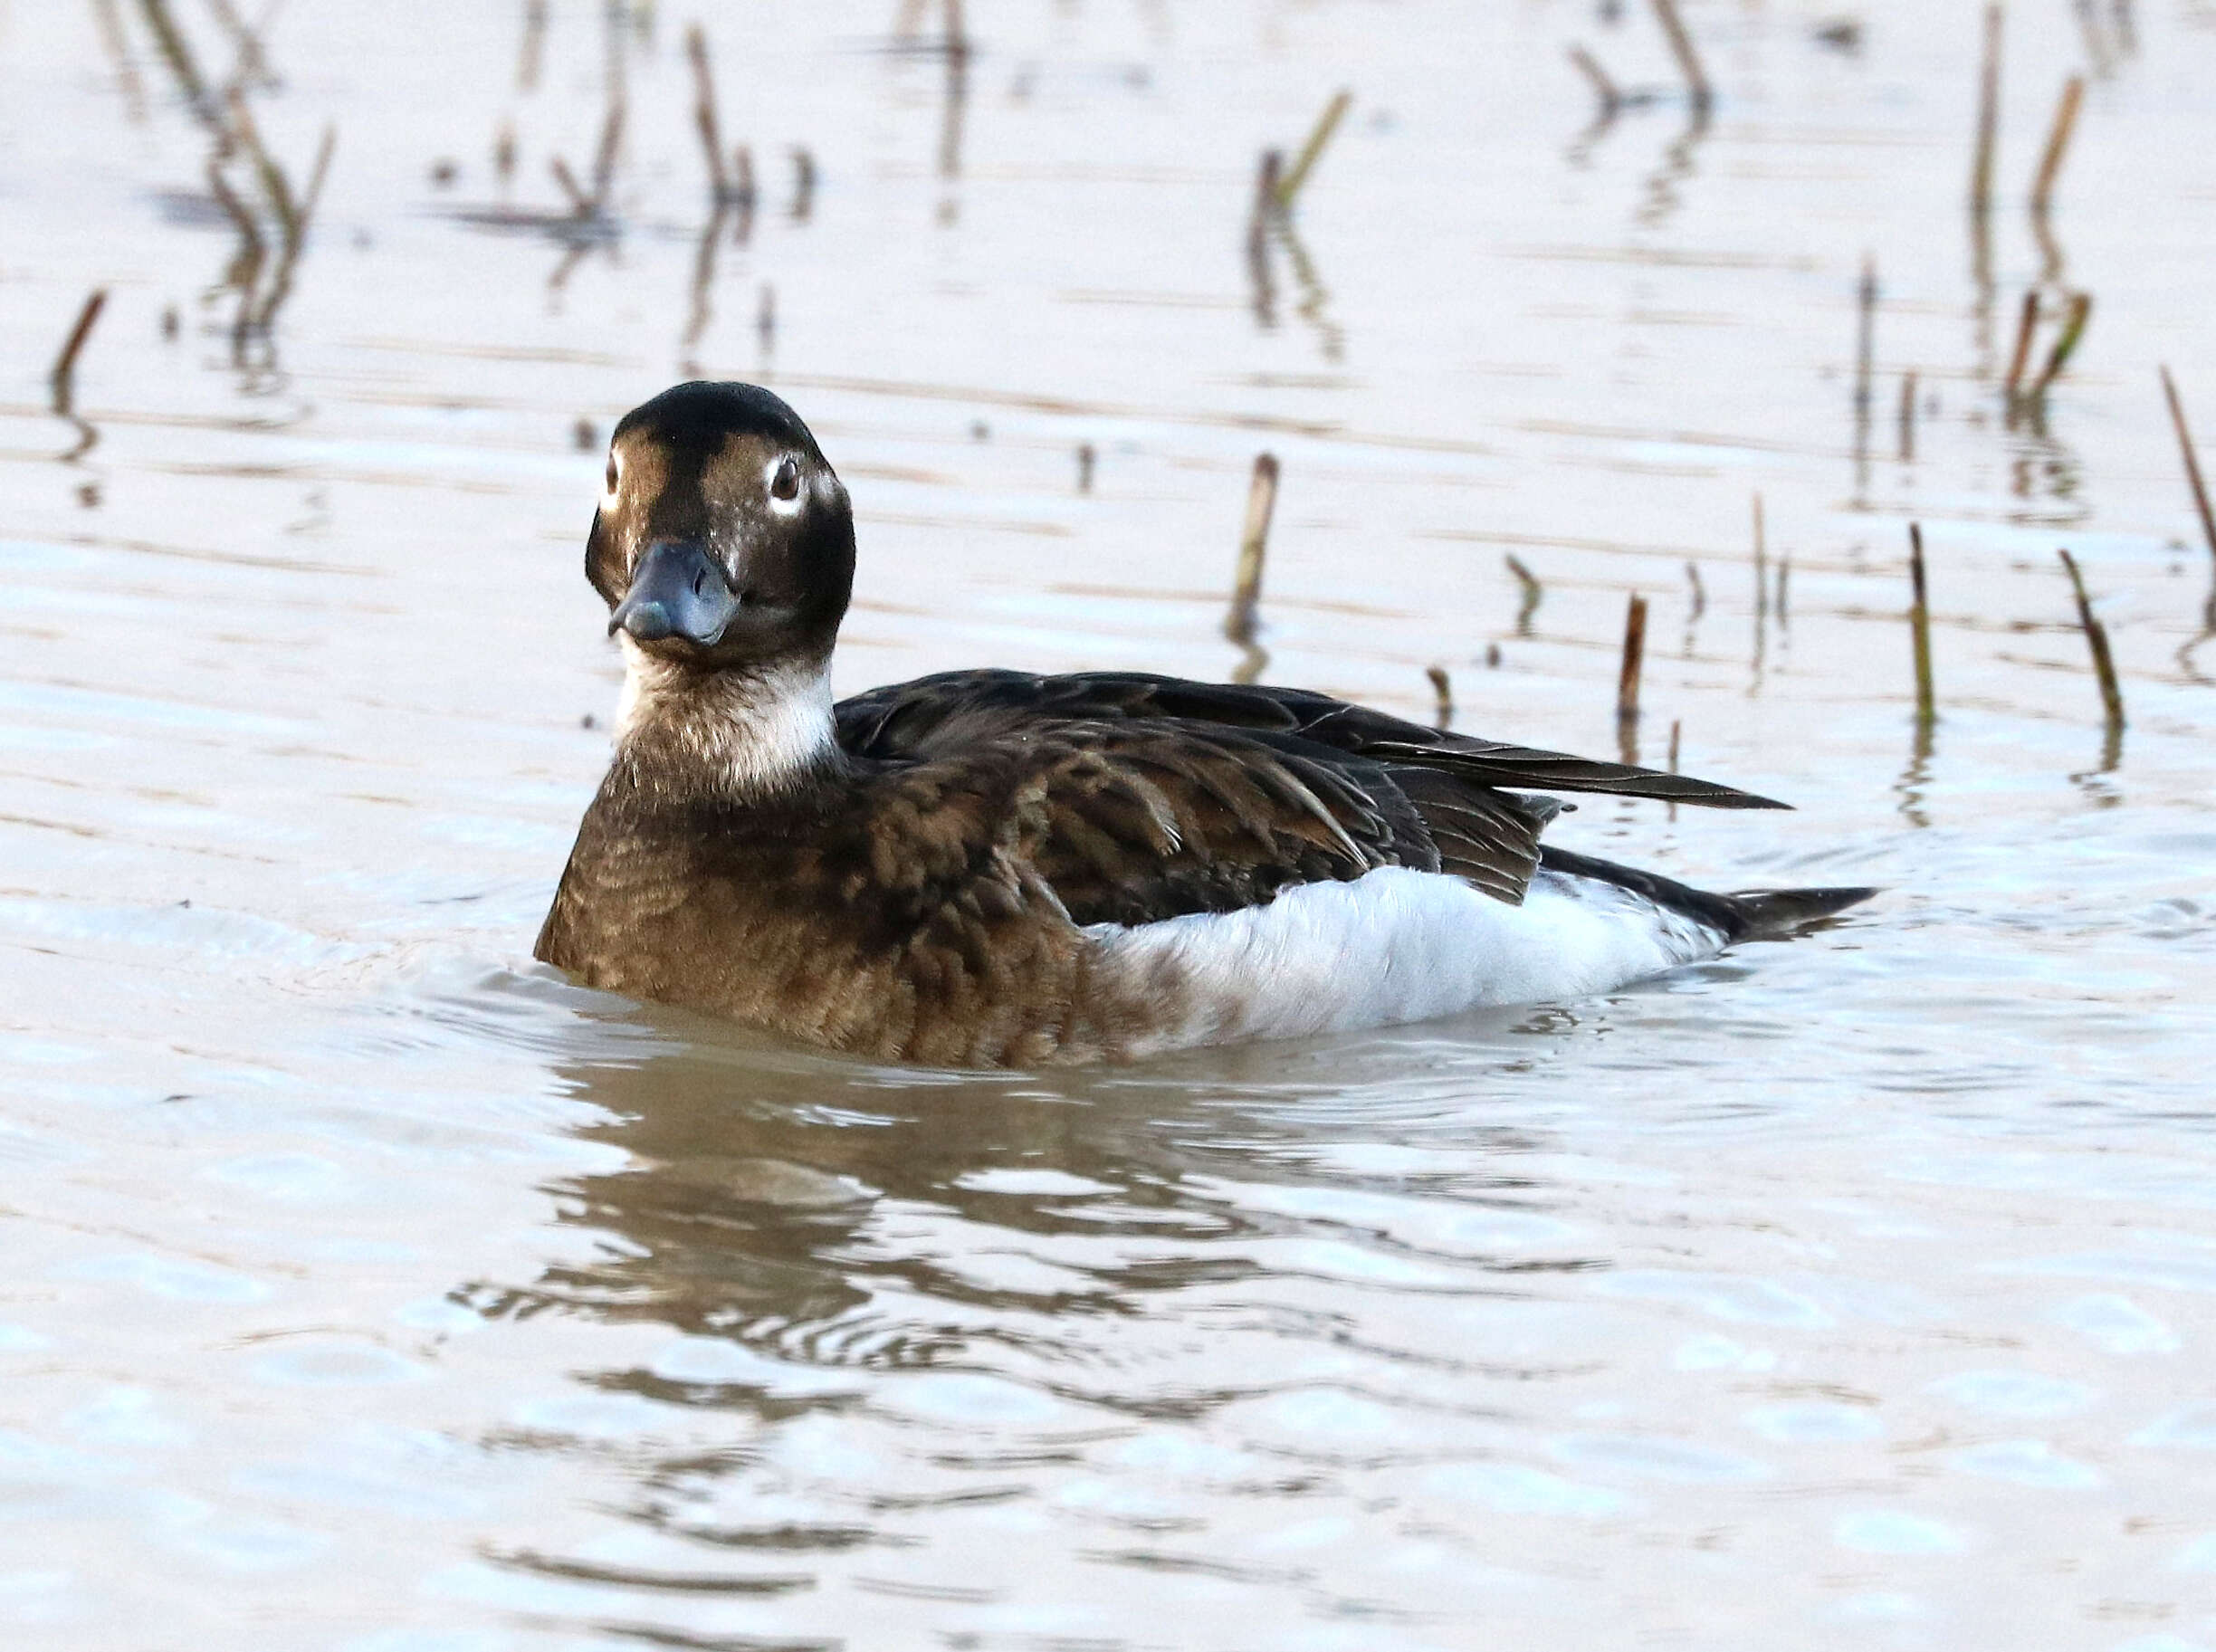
[1086,866,1724,1054]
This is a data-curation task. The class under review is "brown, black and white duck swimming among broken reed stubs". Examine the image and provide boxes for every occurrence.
[534,381,1875,1070]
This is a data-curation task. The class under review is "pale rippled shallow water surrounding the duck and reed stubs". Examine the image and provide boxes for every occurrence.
[0,0,2216,1652]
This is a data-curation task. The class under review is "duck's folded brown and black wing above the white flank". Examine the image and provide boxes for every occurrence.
[836,671,1781,923]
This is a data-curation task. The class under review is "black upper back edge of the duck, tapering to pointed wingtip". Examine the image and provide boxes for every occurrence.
[837,671,1786,808]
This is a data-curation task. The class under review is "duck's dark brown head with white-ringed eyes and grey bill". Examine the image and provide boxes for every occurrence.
[585,381,853,675]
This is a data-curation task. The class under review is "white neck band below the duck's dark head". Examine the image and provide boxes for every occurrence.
[616,631,833,797]
